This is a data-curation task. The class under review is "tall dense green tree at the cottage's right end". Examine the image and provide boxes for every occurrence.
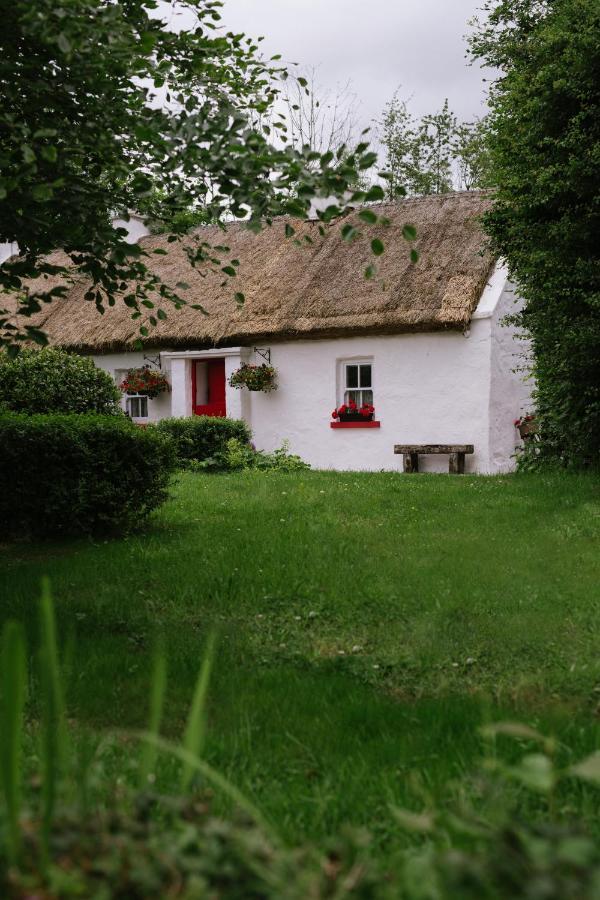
[471,0,600,464]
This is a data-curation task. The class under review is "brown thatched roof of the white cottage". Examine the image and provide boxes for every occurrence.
[4,192,493,352]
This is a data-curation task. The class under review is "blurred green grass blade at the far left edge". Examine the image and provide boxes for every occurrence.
[0,622,27,865]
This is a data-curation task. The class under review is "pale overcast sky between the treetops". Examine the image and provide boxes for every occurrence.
[218,0,485,127]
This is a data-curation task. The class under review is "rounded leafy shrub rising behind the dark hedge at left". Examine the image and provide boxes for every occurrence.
[0,347,121,415]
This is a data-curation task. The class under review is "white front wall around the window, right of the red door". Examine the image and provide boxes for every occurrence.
[244,319,490,471]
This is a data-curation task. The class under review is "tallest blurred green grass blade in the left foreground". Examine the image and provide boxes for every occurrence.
[40,578,68,860]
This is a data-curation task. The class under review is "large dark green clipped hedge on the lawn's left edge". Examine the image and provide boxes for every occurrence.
[0,413,175,536]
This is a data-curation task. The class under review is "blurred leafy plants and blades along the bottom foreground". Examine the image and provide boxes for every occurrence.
[0,596,600,900]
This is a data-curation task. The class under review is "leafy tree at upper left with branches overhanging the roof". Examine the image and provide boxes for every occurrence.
[0,0,383,345]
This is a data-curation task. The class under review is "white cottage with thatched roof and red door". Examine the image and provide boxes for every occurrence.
[23,192,530,473]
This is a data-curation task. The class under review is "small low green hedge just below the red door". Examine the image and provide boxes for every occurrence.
[156,416,252,463]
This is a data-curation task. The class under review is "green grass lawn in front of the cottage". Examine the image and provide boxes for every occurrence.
[0,472,600,839]
